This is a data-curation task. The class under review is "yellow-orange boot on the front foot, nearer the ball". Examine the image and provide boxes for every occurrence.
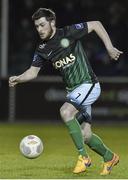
[73,155,91,174]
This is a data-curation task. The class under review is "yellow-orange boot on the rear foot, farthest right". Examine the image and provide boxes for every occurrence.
[100,154,119,176]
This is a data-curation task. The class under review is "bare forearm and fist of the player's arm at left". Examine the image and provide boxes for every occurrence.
[9,66,41,87]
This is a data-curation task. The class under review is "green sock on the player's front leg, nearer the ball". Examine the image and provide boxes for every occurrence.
[66,118,88,157]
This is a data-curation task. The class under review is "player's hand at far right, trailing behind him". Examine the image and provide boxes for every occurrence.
[108,47,123,61]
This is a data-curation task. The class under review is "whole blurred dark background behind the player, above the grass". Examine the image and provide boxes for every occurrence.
[0,0,128,123]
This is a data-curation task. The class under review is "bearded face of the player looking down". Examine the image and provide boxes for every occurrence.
[35,17,53,40]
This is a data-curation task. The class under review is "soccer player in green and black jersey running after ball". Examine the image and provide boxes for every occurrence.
[9,8,123,175]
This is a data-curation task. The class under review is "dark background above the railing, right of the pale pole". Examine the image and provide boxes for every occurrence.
[8,0,128,76]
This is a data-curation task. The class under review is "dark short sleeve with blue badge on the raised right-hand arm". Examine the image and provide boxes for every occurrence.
[65,22,88,39]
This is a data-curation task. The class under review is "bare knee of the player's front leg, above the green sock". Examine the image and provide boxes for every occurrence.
[60,102,78,121]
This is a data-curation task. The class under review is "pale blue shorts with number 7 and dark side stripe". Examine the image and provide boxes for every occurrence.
[67,83,101,109]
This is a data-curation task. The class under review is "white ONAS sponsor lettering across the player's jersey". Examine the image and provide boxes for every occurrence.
[53,54,76,69]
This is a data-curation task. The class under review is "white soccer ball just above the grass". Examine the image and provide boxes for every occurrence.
[20,135,43,159]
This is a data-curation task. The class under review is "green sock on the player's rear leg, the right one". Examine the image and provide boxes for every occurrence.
[87,134,113,162]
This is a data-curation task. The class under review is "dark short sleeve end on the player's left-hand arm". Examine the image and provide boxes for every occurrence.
[31,52,44,67]
